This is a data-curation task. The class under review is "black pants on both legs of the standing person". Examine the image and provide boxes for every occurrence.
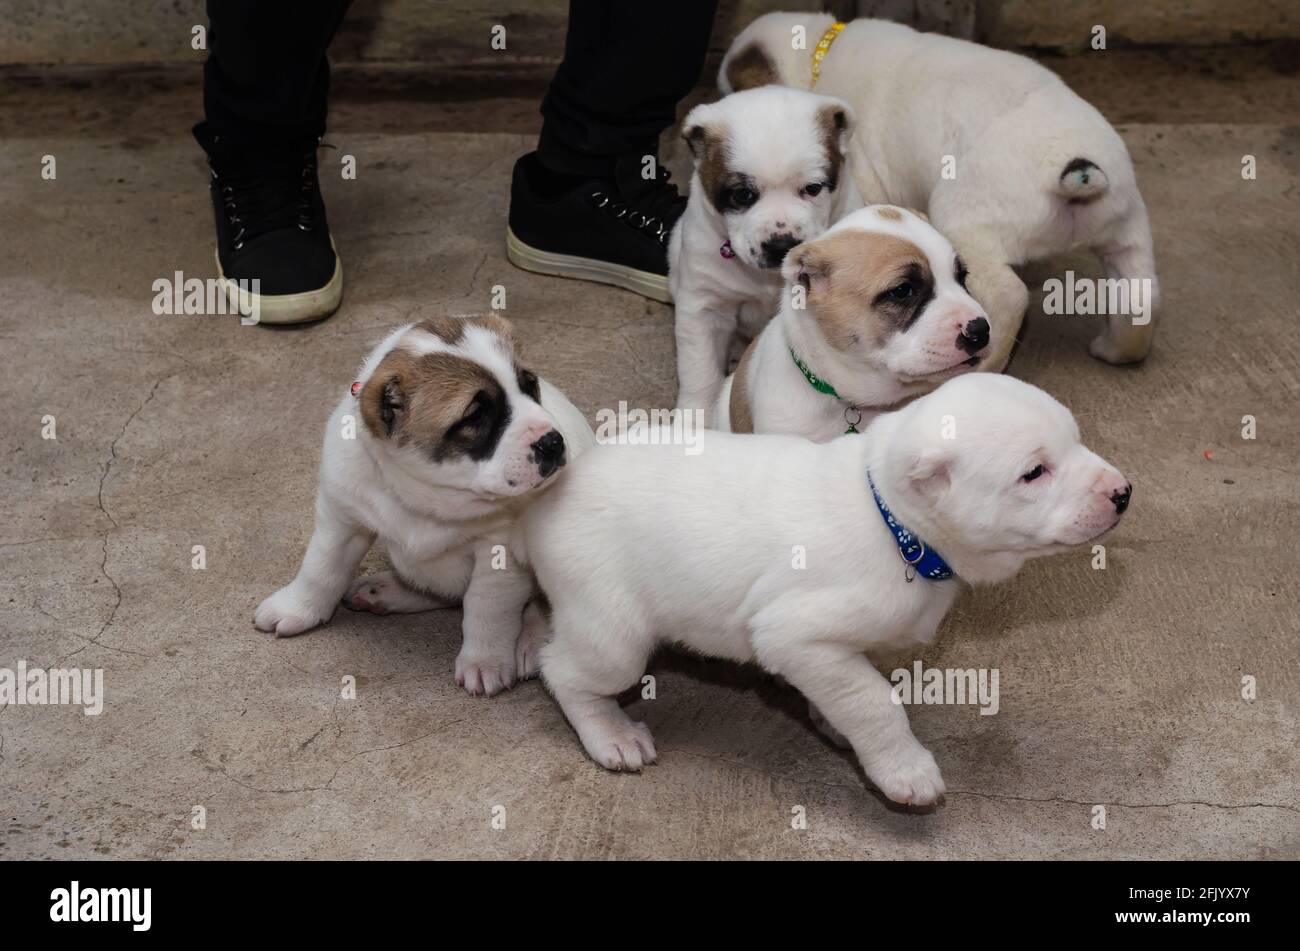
[203,0,718,175]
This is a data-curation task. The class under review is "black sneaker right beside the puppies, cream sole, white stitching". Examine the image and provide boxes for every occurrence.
[506,152,686,304]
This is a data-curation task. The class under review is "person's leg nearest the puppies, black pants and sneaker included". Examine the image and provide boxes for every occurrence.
[506,0,716,301]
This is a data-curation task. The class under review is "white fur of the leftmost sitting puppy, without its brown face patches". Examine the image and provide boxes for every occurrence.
[254,325,595,694]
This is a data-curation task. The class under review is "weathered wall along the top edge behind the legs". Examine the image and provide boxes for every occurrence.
[0,0,1300,71]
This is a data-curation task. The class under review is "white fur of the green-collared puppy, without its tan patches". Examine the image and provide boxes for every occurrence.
[714,205,987,442]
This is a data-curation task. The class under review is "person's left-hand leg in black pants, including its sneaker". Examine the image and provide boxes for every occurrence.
[194,0,348,323]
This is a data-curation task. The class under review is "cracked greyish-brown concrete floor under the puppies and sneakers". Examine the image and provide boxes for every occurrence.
[0,51,1300,859]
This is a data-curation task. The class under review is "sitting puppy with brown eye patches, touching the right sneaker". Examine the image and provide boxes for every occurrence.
[668,86,862,416]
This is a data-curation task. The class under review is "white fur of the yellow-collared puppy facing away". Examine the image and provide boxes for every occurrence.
[719,13,1158,369]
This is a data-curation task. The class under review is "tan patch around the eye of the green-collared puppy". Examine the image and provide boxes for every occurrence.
[790,230,935,349]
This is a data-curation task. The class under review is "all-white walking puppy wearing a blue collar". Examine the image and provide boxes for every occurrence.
[521,373,1131,805]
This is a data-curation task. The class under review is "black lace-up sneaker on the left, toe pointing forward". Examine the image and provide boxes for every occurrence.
[194,123,343,323]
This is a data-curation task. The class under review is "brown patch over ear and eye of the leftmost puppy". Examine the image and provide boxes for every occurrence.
[359,350,501,450]
